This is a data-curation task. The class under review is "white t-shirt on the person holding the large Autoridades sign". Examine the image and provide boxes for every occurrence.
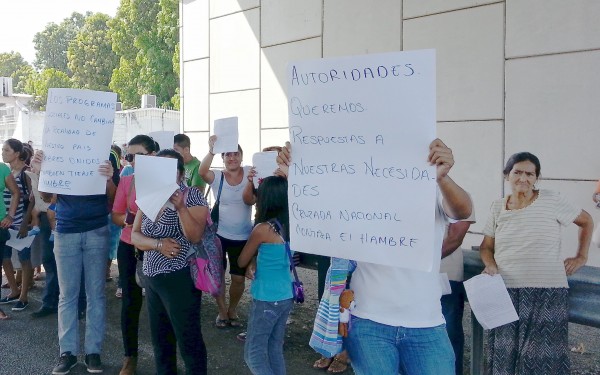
[350,200,451,328]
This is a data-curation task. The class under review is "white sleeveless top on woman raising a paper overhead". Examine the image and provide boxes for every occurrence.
[210,167,252,241]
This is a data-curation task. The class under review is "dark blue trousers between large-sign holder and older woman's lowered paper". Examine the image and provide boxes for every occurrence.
[442,281,465,375]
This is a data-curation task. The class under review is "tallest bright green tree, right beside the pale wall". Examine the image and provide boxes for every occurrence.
[109,0,179,108]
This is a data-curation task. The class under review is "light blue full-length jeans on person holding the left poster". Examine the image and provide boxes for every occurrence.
[54,225,108,355]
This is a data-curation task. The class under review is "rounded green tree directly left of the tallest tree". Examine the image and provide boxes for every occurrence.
[67,13,119,91]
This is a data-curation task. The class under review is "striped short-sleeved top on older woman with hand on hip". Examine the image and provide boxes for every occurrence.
[483,190,581,288]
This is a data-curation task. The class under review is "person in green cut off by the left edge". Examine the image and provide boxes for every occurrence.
[0,159,21,320]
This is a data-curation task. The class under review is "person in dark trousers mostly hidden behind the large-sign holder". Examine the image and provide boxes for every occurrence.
[440,219,475,375]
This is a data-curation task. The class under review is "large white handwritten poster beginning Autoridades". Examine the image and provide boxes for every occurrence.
[287,50,439,271]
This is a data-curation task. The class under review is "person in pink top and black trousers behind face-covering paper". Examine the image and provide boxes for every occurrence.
[112,135,157,375]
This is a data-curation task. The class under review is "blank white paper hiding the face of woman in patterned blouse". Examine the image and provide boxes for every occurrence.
[135,155,179,221]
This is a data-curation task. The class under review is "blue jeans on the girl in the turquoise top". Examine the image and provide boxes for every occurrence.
[244,298,294,375]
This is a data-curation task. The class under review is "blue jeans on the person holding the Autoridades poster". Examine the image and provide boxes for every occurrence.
[345,316,454,375]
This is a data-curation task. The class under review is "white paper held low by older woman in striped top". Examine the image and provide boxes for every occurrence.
[464,274,519,329]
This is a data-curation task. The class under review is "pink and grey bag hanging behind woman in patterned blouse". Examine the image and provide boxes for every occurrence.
[184,188,224,297]
